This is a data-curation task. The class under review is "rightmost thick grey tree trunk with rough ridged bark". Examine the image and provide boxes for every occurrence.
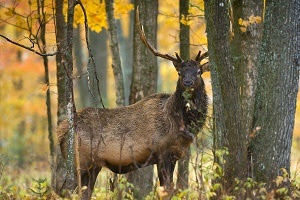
[251,0,300,188]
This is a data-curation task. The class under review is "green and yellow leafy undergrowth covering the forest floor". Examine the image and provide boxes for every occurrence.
[0,147,300,200]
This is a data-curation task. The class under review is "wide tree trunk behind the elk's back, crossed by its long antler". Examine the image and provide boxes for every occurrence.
[128,0,158,199]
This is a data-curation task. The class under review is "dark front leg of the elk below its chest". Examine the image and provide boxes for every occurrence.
[157,155,176,190]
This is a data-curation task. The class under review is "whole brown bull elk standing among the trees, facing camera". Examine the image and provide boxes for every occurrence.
[57,8,208,199]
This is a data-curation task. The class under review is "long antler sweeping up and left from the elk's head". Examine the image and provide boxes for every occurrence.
[136,7,182,63]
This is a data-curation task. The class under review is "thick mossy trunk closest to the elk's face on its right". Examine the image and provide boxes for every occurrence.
[205,0,247,192]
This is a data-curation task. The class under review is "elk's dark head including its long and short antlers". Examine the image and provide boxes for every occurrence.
[136,8,209,89]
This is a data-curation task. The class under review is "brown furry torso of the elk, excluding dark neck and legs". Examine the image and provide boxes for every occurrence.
[57,94,192,173]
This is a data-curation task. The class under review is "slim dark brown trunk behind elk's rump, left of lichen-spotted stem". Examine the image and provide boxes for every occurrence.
[51,0,67,195]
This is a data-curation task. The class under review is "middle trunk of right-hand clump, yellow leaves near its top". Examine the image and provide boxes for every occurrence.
[230,0,264,151]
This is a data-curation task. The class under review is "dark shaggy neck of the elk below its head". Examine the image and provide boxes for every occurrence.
[173,80,208,133]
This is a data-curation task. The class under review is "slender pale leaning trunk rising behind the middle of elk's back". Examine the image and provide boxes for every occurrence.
[105,0,125,106]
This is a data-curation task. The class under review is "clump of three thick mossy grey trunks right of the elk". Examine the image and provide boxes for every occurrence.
[205,0,299,193]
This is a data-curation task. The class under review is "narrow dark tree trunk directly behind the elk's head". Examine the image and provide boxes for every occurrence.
[177,0,191,189]
